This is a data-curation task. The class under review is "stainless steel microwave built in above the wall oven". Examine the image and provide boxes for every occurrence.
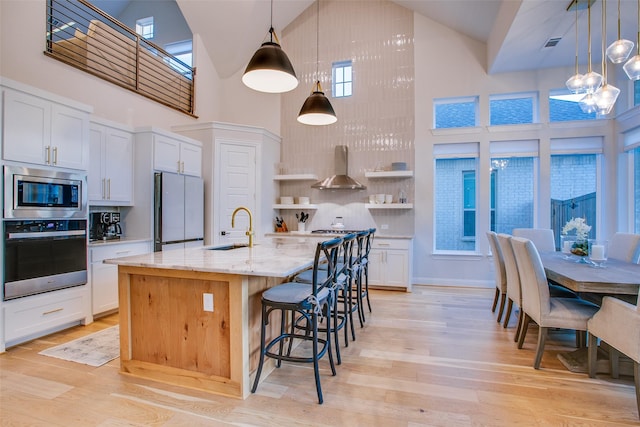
[4,166,87,219]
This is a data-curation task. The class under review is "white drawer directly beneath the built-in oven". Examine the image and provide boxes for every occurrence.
[4,285,89,342]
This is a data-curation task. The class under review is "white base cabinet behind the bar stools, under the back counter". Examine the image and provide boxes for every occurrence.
[369,236,413,292]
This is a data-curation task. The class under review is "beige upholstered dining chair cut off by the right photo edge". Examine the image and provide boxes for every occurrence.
[587,290,640,417]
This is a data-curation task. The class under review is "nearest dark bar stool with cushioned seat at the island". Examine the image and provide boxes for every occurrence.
[251,237,342,404]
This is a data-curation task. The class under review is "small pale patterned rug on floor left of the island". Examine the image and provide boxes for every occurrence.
[39,325,120,366]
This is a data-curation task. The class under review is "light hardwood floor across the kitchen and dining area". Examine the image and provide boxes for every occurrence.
[0,286,640,426]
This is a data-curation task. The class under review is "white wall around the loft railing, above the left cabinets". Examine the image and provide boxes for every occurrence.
[0,0,280,134]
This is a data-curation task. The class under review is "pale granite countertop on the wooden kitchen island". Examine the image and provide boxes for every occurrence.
[104,238,324,277]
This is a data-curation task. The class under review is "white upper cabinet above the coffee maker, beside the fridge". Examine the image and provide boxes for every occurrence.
[88,123,133,206]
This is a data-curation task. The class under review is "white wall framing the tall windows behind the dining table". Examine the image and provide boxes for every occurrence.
[413,14,617,286]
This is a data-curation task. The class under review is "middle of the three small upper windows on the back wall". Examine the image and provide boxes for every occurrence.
[489,93,538,126]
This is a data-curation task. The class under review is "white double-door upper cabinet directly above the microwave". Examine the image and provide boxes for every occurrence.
[2,87,89,170]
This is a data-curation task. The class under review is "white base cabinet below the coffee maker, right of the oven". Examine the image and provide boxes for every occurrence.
[89,241,151,315]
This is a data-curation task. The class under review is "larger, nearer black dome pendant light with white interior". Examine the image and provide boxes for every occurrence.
[242,0,298,93]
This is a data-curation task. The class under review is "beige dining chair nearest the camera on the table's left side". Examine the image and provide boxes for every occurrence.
[511,237,598,369]
